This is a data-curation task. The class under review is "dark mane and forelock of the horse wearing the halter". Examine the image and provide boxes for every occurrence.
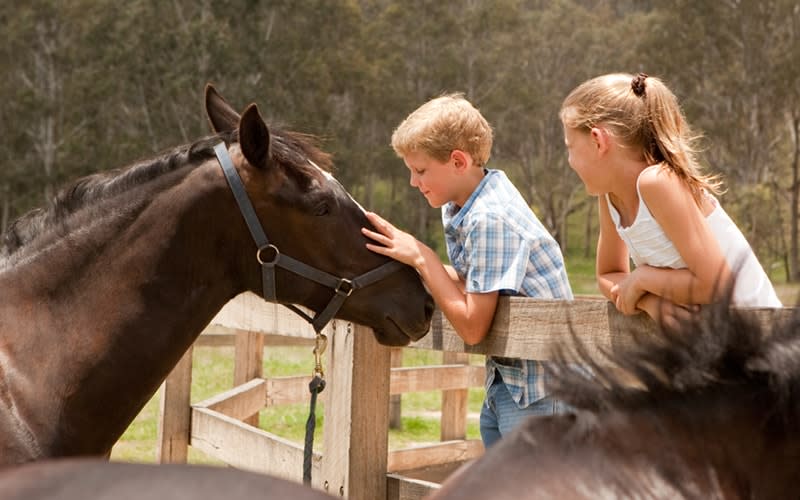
[0,128,333,264]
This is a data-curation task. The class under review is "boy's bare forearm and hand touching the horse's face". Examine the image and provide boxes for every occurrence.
[361,212,499,345]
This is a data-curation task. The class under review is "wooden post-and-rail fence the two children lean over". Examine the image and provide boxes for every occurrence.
[158,294,789,500]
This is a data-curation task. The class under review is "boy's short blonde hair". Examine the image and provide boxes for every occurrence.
[392,93,492,167]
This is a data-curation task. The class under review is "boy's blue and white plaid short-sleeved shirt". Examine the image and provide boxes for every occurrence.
[442,170,572,408]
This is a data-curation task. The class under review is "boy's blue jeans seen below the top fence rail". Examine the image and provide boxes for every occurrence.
[480,373,569,449]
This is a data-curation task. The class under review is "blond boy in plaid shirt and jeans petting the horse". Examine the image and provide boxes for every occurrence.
[362,94,572,448]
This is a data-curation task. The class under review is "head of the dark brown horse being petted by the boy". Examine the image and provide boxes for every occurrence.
[205,85,433,345]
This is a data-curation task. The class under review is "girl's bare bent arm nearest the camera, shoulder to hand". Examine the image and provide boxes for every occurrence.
[618,168,731,308]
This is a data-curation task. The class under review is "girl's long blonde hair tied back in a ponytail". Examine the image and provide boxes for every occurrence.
[559,73,722,203]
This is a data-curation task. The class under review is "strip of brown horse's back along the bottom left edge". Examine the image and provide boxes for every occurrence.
[0,459,336,500]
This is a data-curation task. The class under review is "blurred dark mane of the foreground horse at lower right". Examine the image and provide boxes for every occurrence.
[548,299,800,412]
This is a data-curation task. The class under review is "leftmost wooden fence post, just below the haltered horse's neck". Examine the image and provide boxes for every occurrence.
[156,346,194,464]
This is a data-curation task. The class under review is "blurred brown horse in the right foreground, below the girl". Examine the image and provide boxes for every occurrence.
[432,304,800,500]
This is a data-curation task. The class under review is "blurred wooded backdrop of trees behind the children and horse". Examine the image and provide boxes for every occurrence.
[0,0,800,275]
